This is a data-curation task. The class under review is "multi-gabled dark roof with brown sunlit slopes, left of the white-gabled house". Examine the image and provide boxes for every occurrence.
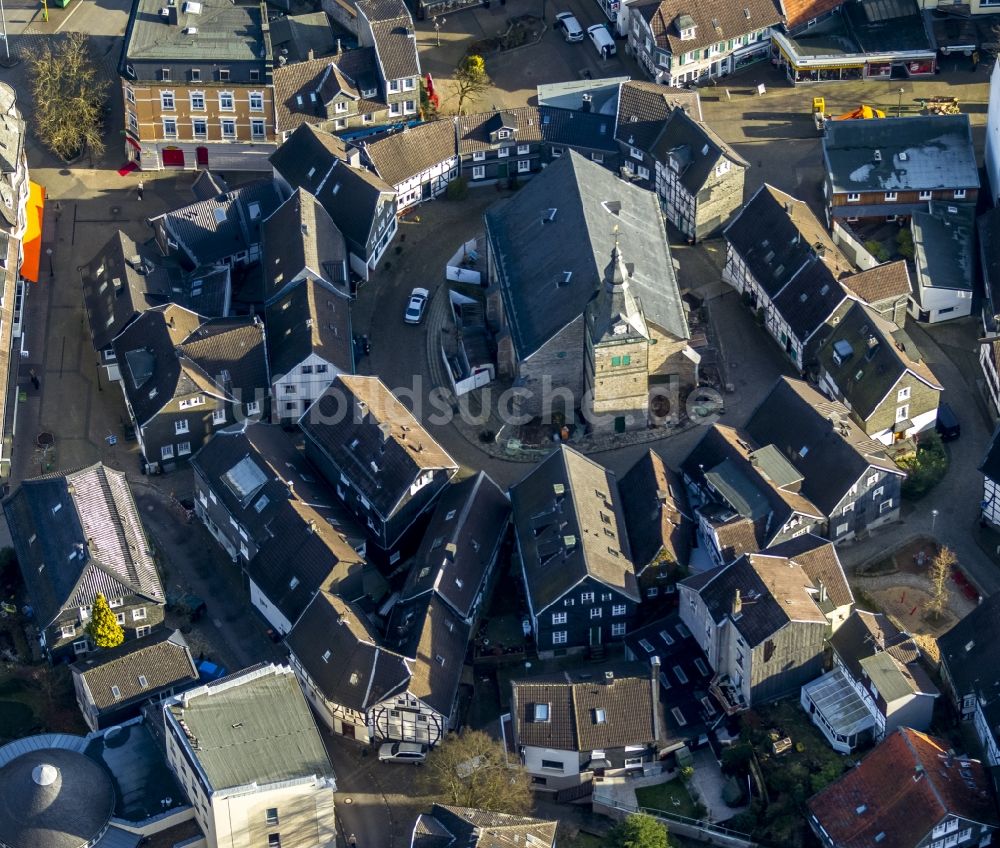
[113,304,270,426]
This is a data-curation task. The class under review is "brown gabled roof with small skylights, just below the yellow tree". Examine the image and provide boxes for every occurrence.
[70,630,198,711]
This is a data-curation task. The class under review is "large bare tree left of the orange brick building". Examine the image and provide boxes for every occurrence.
[27,32,109,159]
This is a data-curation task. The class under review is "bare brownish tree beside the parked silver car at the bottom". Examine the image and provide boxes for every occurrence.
[422,730,531,815]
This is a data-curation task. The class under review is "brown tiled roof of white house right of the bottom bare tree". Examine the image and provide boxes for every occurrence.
[511,663,659,751]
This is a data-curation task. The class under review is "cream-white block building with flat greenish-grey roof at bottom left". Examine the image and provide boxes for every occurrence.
[164,665,337,848]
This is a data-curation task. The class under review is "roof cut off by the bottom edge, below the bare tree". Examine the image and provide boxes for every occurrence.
[418,804,559,848]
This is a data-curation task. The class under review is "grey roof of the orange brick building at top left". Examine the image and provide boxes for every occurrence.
[122,0,265,63]
